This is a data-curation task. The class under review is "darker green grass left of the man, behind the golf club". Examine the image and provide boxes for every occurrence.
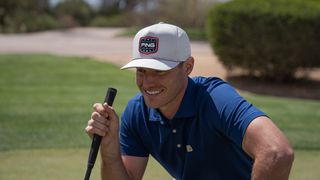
[0,55,137,150]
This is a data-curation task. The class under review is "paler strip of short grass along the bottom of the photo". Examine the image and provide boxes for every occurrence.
[0,148,320,180]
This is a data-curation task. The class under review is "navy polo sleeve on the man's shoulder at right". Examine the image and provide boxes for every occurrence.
[210,80,266,147]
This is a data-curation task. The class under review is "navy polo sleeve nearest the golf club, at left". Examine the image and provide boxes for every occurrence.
[120,102,149,157]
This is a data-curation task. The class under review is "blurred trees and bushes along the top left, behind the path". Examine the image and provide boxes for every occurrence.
[0,0,215,33]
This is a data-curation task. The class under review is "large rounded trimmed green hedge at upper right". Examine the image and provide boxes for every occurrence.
[207,0,320,81]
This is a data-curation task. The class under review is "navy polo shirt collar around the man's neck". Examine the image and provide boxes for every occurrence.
[148,77,196,121]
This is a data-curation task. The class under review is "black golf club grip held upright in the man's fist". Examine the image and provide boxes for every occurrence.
[85,88,117,180]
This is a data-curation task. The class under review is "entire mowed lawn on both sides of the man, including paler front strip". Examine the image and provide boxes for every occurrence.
[0,54,320,180]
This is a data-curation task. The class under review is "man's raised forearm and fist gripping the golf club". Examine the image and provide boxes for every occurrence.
[85,103,148,180]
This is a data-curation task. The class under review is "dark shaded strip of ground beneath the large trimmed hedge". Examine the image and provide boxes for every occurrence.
[227,75,320,100]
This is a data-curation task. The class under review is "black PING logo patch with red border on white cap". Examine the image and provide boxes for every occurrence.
[139,36,159,54]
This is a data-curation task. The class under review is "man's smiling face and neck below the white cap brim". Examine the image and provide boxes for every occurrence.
[136,58,193,119]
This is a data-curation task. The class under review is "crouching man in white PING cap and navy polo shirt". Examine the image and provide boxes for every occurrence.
[86,23,293,180]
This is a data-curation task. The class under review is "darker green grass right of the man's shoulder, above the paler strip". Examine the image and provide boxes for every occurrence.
[245,95,320,150]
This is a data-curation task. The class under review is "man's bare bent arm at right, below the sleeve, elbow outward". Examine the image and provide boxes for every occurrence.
[242,116,294,180]
